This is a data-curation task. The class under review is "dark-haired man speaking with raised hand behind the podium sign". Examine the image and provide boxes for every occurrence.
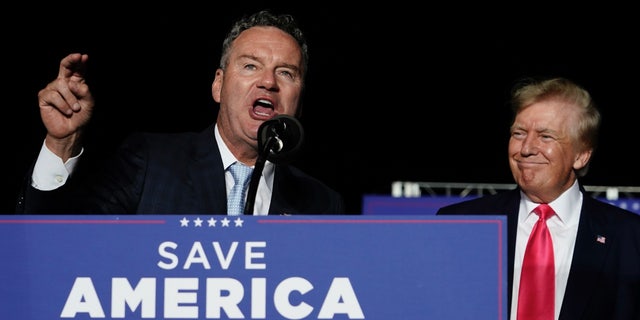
[16,11,343,215]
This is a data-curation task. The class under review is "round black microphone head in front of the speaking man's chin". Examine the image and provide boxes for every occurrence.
[258,114,304,163]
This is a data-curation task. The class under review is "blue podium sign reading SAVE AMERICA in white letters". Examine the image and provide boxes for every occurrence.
[0,215,507,320]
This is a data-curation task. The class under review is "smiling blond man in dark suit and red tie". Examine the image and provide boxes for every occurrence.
[437,78,640,320]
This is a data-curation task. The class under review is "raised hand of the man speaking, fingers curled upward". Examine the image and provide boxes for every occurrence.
[38,53,95,161]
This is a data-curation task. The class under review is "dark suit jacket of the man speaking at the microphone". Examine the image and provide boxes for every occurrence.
[16,125,344,215]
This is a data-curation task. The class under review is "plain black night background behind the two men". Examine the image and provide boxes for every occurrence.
[6,2,640,214]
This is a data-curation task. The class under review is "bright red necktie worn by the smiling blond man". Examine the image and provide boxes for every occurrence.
[517,203,555,320]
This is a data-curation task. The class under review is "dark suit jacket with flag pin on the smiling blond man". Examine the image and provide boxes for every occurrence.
[437,187,640,320]
